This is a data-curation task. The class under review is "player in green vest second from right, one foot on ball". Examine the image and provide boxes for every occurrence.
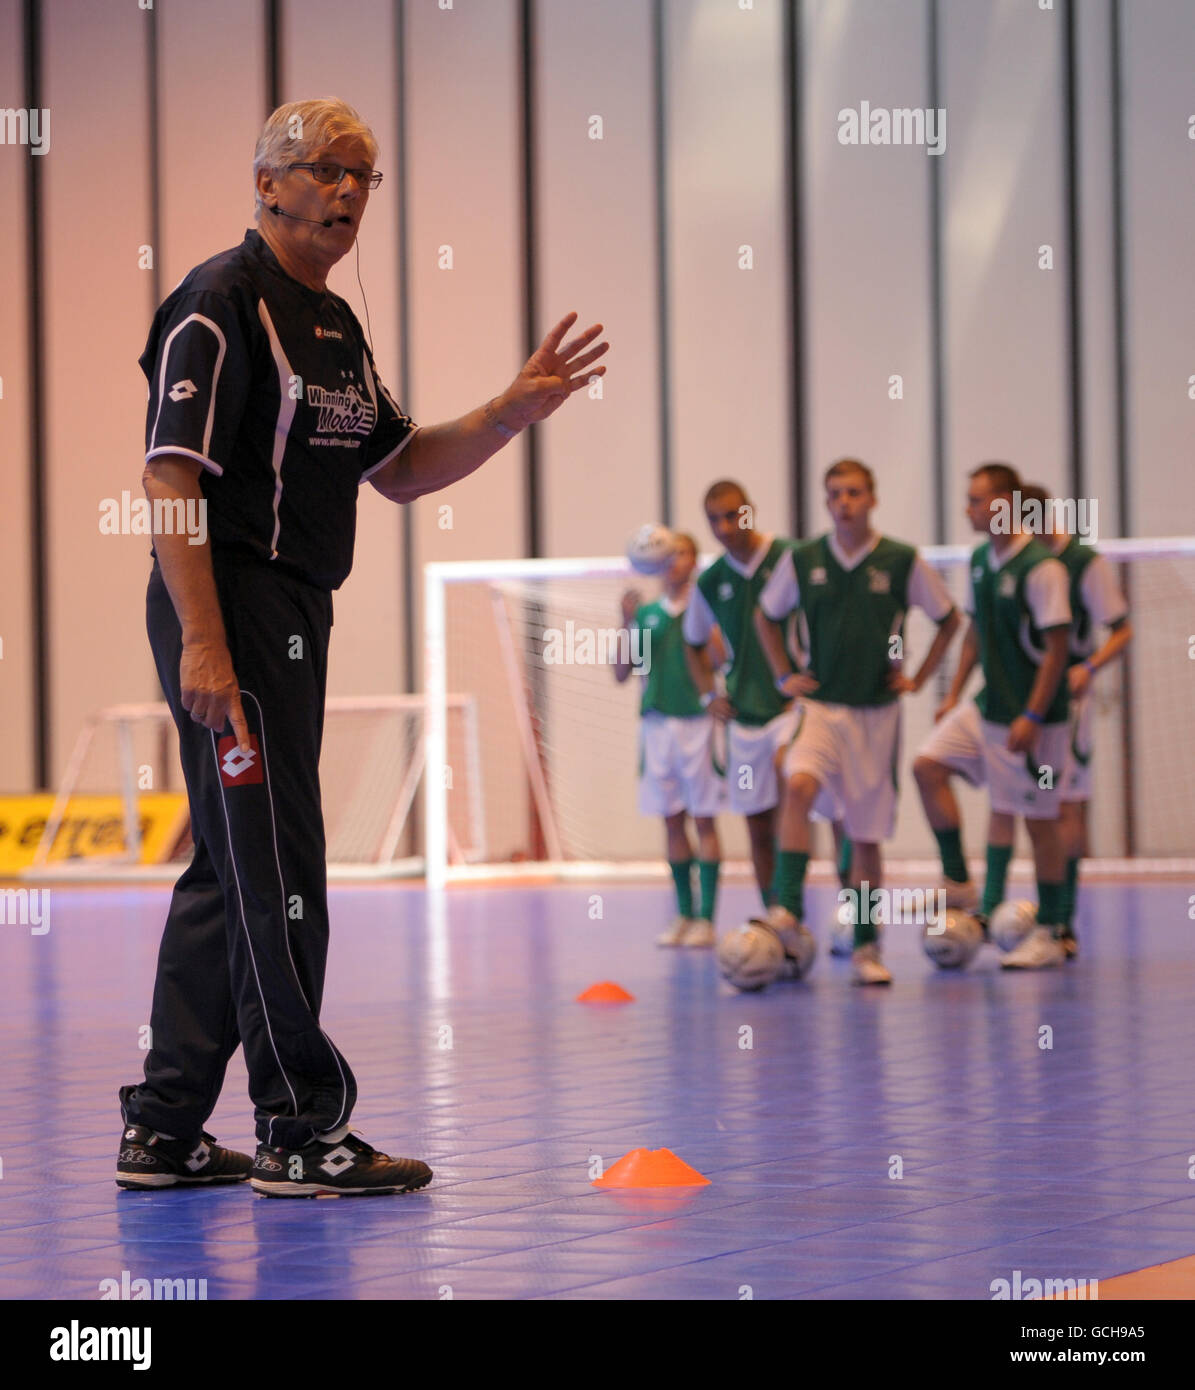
[913,463,1071,969]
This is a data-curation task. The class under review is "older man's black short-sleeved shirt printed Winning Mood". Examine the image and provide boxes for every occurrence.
[140,229,415,589]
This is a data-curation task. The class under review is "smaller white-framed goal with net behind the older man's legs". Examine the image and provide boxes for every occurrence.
[28,694,491,880]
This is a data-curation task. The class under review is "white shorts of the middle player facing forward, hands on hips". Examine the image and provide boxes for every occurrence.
[784,699,900,844]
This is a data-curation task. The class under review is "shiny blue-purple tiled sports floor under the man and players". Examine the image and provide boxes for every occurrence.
[0,883,1195,1300]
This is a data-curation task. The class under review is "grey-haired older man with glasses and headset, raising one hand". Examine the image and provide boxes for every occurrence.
[117,100,607,1197]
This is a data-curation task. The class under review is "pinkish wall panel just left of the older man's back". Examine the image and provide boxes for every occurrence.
[42,6,156,783]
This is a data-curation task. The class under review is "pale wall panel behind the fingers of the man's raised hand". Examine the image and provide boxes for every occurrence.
[536,0,661,555]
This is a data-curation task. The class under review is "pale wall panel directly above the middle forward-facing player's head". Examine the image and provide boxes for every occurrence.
[803,0,945,543]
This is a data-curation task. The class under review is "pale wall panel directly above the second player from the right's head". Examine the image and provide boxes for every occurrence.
[939,0,1069,541]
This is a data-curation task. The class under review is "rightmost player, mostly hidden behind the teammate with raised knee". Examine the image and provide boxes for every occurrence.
[981,482,1132,959]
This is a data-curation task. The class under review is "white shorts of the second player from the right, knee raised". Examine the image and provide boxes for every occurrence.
[917,699,1067,820]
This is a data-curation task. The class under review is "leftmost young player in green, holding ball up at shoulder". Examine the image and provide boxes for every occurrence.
[614,534,724,947]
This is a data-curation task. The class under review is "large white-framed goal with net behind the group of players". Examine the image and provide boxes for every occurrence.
[424,539,1195,885]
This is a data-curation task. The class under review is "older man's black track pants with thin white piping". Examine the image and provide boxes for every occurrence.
[121,556,357,1148]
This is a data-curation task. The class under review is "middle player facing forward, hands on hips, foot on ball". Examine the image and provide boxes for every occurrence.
[756,459,959,984]
